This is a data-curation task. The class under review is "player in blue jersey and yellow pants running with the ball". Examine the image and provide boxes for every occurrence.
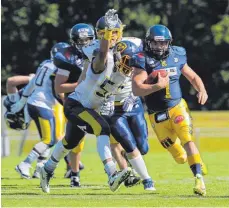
[131,25,208,196]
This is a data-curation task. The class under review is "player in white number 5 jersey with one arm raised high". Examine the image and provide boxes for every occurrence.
[41,10,131,193]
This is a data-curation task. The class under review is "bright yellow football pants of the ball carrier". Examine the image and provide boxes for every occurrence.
[149,99,193,163]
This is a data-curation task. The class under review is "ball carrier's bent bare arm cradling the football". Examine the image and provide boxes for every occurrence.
[132,67,169,96]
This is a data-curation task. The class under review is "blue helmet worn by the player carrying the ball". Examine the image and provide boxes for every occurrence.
[145,25,172,60]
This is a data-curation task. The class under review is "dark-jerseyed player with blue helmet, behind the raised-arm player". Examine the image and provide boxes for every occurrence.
[52,23,95,187]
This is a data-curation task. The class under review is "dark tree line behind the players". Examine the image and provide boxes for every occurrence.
[1,0,229,110]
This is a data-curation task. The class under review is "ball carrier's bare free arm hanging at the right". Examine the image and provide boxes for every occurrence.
[182,64,208,105]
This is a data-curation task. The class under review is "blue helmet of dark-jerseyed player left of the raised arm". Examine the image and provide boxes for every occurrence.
[69,23,95,50]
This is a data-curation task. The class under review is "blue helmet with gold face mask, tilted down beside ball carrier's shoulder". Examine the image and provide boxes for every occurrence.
[114,40,140,76]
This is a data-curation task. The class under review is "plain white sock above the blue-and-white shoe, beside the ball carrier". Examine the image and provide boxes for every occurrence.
[129,155,151,180]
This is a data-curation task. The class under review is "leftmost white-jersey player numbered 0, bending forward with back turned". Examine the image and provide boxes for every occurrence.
[11,44,67,179]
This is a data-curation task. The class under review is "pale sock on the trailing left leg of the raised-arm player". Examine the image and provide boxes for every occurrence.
[44,141,70,173]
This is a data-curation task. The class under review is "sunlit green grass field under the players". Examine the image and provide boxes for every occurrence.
[1,112,229,207]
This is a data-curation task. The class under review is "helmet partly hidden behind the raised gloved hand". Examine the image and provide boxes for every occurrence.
[95,16,125,42]
